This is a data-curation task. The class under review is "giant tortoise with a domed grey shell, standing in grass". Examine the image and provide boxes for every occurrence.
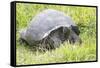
[20,9,81,49]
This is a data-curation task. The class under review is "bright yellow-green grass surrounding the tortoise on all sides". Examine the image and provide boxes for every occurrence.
[16,3,96,65]
